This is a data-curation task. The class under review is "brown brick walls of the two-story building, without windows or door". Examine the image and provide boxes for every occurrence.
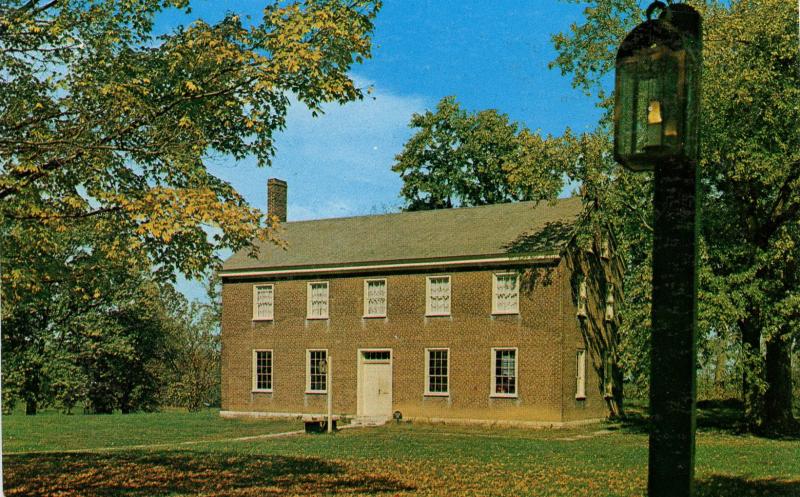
[222,264,603,422]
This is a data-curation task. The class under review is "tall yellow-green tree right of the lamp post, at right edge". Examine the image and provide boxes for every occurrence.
[703,0,800,430]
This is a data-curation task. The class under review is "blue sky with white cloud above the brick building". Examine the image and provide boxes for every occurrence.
[157,0,600,298]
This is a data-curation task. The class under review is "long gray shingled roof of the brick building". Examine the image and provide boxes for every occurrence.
[222,197,581,271]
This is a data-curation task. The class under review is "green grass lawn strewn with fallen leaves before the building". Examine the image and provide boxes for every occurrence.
[3,413,800,497]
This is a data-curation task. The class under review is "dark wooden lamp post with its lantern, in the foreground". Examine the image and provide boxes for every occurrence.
[614,1,702,497]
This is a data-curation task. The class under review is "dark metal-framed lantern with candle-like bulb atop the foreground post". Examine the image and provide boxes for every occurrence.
[614,1,701,171]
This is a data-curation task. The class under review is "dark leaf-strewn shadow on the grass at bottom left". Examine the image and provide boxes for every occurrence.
[5,450,415,497]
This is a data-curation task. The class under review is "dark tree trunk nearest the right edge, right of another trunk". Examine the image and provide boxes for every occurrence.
[763,335,797,433]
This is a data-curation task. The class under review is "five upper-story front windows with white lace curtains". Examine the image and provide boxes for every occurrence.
[253,273,519,321]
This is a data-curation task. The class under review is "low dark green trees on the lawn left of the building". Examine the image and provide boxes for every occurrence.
[3,234,218,413]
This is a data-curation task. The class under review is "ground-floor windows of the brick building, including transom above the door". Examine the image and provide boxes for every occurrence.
[253,347,586,399]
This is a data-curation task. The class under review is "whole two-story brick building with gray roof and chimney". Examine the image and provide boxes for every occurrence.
[221,180,615,425]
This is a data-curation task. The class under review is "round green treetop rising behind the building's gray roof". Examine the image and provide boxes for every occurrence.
[392,97,562,210]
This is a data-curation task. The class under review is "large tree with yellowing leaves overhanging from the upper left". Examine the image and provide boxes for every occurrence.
[0,0,380,412]
